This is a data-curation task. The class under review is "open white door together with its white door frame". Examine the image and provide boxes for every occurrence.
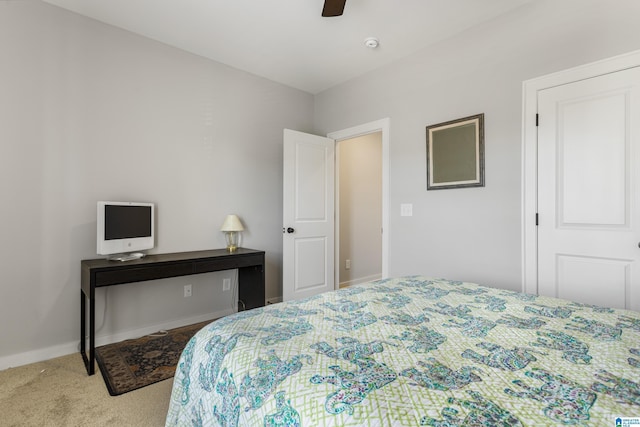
[282,118,390,301]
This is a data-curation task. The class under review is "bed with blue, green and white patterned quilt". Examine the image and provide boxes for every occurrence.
[166,276,640,427]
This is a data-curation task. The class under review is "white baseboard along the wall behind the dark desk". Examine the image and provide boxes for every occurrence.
[0,309,233,371]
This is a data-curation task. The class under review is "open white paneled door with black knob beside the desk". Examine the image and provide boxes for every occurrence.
[282,129,335,301]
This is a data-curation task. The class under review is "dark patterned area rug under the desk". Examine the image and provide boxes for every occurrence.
[96,321,211,396]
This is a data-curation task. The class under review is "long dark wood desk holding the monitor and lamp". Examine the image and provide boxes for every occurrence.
[80,248,265,375]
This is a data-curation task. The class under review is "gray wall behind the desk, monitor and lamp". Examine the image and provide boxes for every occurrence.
[0,1,313,369]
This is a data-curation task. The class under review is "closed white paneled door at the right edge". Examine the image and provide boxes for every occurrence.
[538,68,640,310]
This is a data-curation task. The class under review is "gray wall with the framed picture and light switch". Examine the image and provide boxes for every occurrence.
[314,0,640,290]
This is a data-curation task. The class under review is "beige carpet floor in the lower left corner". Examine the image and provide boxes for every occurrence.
[0,353,173,427]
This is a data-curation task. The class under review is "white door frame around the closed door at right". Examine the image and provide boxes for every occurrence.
[521,50,640,295]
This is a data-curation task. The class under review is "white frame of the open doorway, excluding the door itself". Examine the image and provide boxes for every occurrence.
[327,117,391,286]
